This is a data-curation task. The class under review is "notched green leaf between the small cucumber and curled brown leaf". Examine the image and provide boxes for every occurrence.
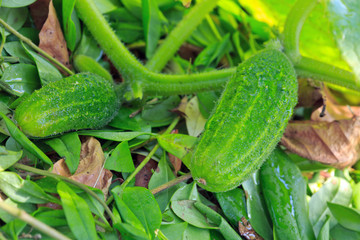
[45,133,81,174]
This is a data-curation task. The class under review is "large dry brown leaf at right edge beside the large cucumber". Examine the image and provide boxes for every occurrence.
[281,117,360,168]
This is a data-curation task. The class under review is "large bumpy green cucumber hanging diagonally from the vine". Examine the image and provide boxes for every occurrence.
[190,49,298,192]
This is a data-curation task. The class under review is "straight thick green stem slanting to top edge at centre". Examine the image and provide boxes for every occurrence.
[145,0,219,72]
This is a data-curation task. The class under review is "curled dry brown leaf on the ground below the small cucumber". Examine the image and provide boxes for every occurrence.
[52,137,112,197]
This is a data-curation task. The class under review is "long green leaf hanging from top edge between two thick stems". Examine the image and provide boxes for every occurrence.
[141,0,161,59]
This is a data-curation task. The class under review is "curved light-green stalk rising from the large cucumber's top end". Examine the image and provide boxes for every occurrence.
[283,0,318,64]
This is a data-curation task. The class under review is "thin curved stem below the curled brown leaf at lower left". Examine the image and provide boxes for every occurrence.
[13,163,115,221]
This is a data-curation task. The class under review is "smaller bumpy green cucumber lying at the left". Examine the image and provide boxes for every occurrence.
[15,73,119,137]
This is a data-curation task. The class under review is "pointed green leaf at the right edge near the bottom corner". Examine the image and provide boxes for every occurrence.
[327,202,360,231]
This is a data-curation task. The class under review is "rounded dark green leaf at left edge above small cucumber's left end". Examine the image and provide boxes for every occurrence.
[0,63,40,96]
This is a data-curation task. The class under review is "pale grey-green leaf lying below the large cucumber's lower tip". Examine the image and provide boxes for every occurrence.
[171,200,218,229]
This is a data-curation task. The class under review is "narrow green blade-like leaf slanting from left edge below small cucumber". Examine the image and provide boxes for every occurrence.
[0,112,53,165]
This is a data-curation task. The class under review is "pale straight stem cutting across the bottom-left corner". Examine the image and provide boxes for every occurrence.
[0,200,70,240]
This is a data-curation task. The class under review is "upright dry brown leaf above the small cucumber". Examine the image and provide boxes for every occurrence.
[39,1,70,67]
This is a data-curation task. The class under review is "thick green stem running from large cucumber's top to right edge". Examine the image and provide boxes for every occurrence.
[295,57,360,91]
